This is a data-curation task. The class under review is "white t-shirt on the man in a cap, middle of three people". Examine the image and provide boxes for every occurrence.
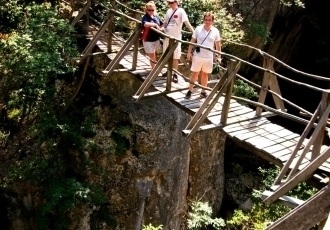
[164,7,188,39]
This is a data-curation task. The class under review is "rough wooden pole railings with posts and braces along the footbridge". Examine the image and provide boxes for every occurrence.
[71,0,330,223]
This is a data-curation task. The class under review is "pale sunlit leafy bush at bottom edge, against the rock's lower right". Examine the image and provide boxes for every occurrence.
[187,201,225,230]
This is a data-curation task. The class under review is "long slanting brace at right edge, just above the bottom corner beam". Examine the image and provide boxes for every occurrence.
[264,147,330,205]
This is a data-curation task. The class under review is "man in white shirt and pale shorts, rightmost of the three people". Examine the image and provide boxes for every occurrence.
[186,12,221,98]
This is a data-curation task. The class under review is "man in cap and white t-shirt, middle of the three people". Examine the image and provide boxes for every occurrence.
[163,0,194,82]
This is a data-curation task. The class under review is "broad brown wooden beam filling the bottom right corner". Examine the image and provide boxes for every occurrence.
[266,186,330,230]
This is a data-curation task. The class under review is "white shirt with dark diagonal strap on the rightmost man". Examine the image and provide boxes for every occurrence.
[192,25,221,58]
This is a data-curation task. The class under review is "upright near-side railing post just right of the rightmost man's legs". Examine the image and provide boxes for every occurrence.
[220,60,237,125]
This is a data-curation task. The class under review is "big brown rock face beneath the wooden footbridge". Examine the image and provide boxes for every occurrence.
[84,69,225,229]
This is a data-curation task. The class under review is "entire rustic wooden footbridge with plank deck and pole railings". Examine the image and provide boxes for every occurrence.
[72,0,330,229]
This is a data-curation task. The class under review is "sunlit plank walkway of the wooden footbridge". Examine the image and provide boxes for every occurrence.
[90,34,330,177]
